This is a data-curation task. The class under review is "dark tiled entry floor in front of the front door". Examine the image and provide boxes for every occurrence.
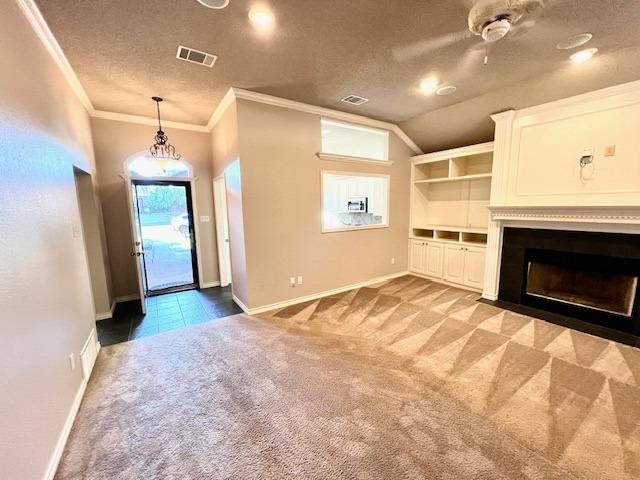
[96,286,242,347]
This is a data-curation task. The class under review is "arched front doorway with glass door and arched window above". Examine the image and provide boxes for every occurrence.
[124,153,199,310]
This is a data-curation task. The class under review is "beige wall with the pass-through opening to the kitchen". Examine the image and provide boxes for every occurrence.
[238,100,412,308]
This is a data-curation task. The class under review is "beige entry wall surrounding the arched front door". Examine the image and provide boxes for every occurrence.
[91,118,219,298]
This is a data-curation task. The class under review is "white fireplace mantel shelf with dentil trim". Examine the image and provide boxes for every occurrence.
[489,205,640,225]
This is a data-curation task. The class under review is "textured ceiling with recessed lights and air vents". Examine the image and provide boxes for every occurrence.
[37,0,640,151]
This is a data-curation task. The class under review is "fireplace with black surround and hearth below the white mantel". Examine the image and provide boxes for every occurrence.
[498,228,640,336]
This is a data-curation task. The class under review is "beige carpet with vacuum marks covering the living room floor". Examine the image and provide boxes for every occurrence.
[56,277,640,480]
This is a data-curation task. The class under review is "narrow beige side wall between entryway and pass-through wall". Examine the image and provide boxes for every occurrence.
[211,102,248,305]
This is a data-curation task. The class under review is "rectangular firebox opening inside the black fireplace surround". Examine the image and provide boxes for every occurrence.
[526,261,638,317]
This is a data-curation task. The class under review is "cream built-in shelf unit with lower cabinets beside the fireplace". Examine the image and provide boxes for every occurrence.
[409,143,493,290]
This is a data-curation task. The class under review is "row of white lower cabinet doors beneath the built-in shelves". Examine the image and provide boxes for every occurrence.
[409,239,486,290]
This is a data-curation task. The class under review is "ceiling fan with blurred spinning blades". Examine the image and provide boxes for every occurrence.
[393,0,558,65]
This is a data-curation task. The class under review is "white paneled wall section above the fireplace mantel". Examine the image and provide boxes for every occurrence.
[491,82,640,206]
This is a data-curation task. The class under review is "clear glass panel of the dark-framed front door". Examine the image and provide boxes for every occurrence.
[136,184,195,292]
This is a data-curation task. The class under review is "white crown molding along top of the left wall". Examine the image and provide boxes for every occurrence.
[17,0,94,114]
